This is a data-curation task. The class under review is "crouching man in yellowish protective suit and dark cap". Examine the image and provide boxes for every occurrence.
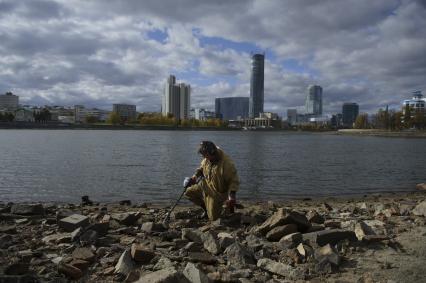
[185,141,240,221]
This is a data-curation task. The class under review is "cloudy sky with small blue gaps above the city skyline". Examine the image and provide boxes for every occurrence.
[0,0,426,116]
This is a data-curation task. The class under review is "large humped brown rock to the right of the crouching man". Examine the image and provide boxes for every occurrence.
[255,208,311,235]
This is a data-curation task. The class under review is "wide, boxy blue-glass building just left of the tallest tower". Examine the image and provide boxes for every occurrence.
[215,97,249,120]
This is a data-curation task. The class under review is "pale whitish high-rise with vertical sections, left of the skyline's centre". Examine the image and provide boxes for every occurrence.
[161,75,191,119]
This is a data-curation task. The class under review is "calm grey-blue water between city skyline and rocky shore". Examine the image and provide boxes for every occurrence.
[0,130,426,202]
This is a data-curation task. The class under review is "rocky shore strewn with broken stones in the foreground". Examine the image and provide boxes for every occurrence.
[0,187,426,283]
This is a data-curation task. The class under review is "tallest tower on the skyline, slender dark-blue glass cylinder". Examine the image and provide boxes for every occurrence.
[249,54,265,118]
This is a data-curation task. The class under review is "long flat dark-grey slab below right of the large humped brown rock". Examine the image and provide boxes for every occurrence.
[303,229,357,246]
